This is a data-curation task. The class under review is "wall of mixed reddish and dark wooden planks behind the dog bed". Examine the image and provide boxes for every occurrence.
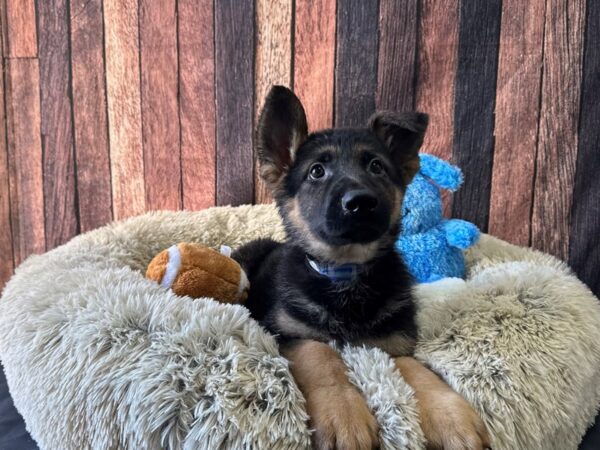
[0,0,600,293]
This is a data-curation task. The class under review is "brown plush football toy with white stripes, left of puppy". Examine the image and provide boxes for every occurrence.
[146,243,250,303]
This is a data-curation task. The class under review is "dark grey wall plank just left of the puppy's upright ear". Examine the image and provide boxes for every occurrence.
[215,0,254,205]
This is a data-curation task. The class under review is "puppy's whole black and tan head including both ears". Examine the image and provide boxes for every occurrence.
[257,86,427,263]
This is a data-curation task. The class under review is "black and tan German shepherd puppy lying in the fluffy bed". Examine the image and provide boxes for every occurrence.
[233,86,489,450]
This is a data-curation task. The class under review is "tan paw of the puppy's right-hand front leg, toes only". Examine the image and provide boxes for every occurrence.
[418,388,491,450]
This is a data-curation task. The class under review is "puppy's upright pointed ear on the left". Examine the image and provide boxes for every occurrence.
[256,86,308,189]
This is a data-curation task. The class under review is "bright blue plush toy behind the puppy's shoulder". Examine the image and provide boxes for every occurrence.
[396,154,479,283]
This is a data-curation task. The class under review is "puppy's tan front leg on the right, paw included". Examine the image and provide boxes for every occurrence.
[395,357,490,450]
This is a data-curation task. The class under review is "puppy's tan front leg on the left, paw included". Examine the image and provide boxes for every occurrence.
[282,339,379,450]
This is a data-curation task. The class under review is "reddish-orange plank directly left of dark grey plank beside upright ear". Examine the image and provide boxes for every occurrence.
[177,0,217,210]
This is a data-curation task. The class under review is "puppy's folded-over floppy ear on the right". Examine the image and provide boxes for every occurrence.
[369,111,429,184]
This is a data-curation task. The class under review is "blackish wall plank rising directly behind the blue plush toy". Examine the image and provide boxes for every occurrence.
[452,0,501,231]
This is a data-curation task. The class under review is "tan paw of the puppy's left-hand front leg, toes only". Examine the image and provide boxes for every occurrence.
[306,387,379,450]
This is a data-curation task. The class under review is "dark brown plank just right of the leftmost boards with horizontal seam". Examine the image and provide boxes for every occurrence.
[38,0,78,250]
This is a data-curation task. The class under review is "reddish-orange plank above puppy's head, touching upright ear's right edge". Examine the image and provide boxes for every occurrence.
[294,0,336,131]
